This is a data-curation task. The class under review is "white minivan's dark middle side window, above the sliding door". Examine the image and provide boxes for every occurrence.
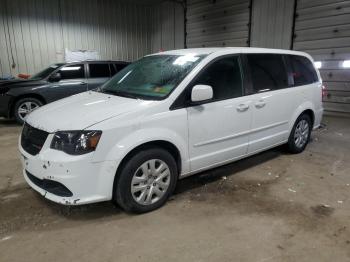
[247,54,288,92]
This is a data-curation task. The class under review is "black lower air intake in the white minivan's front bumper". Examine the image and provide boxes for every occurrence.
[26,170,73,197]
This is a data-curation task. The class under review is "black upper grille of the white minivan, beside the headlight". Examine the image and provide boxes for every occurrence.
[21,123,49,156]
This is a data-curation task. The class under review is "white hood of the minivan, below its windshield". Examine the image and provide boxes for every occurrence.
[26,91,155,133]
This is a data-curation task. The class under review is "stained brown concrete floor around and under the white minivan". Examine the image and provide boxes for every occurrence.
[0,117,350,262]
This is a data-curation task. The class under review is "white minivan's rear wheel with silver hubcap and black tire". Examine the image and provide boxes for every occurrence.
[287,114,312,154]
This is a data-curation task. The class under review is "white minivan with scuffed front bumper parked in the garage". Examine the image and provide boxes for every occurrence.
[19,48,323,213]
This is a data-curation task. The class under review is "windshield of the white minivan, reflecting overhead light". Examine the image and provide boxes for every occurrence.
[99,54,205,100]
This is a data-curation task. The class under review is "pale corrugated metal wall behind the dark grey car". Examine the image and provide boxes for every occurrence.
[0,0,184,76]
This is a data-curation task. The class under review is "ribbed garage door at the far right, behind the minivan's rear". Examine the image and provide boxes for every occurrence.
[293,0,350,112]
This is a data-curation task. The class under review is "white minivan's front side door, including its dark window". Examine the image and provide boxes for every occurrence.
[187,55,252,171]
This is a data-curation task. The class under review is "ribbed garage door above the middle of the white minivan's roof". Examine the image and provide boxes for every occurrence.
[186,0,250,48]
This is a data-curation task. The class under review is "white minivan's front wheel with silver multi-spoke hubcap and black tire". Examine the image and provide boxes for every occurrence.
[114,148,178,213]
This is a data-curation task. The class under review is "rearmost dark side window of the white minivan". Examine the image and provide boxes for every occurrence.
[288,55,318,86]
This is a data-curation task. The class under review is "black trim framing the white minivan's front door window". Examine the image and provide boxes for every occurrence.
[169,54,248,110]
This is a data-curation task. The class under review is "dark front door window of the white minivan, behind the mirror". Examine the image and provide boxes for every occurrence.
[194,56,243,100]
